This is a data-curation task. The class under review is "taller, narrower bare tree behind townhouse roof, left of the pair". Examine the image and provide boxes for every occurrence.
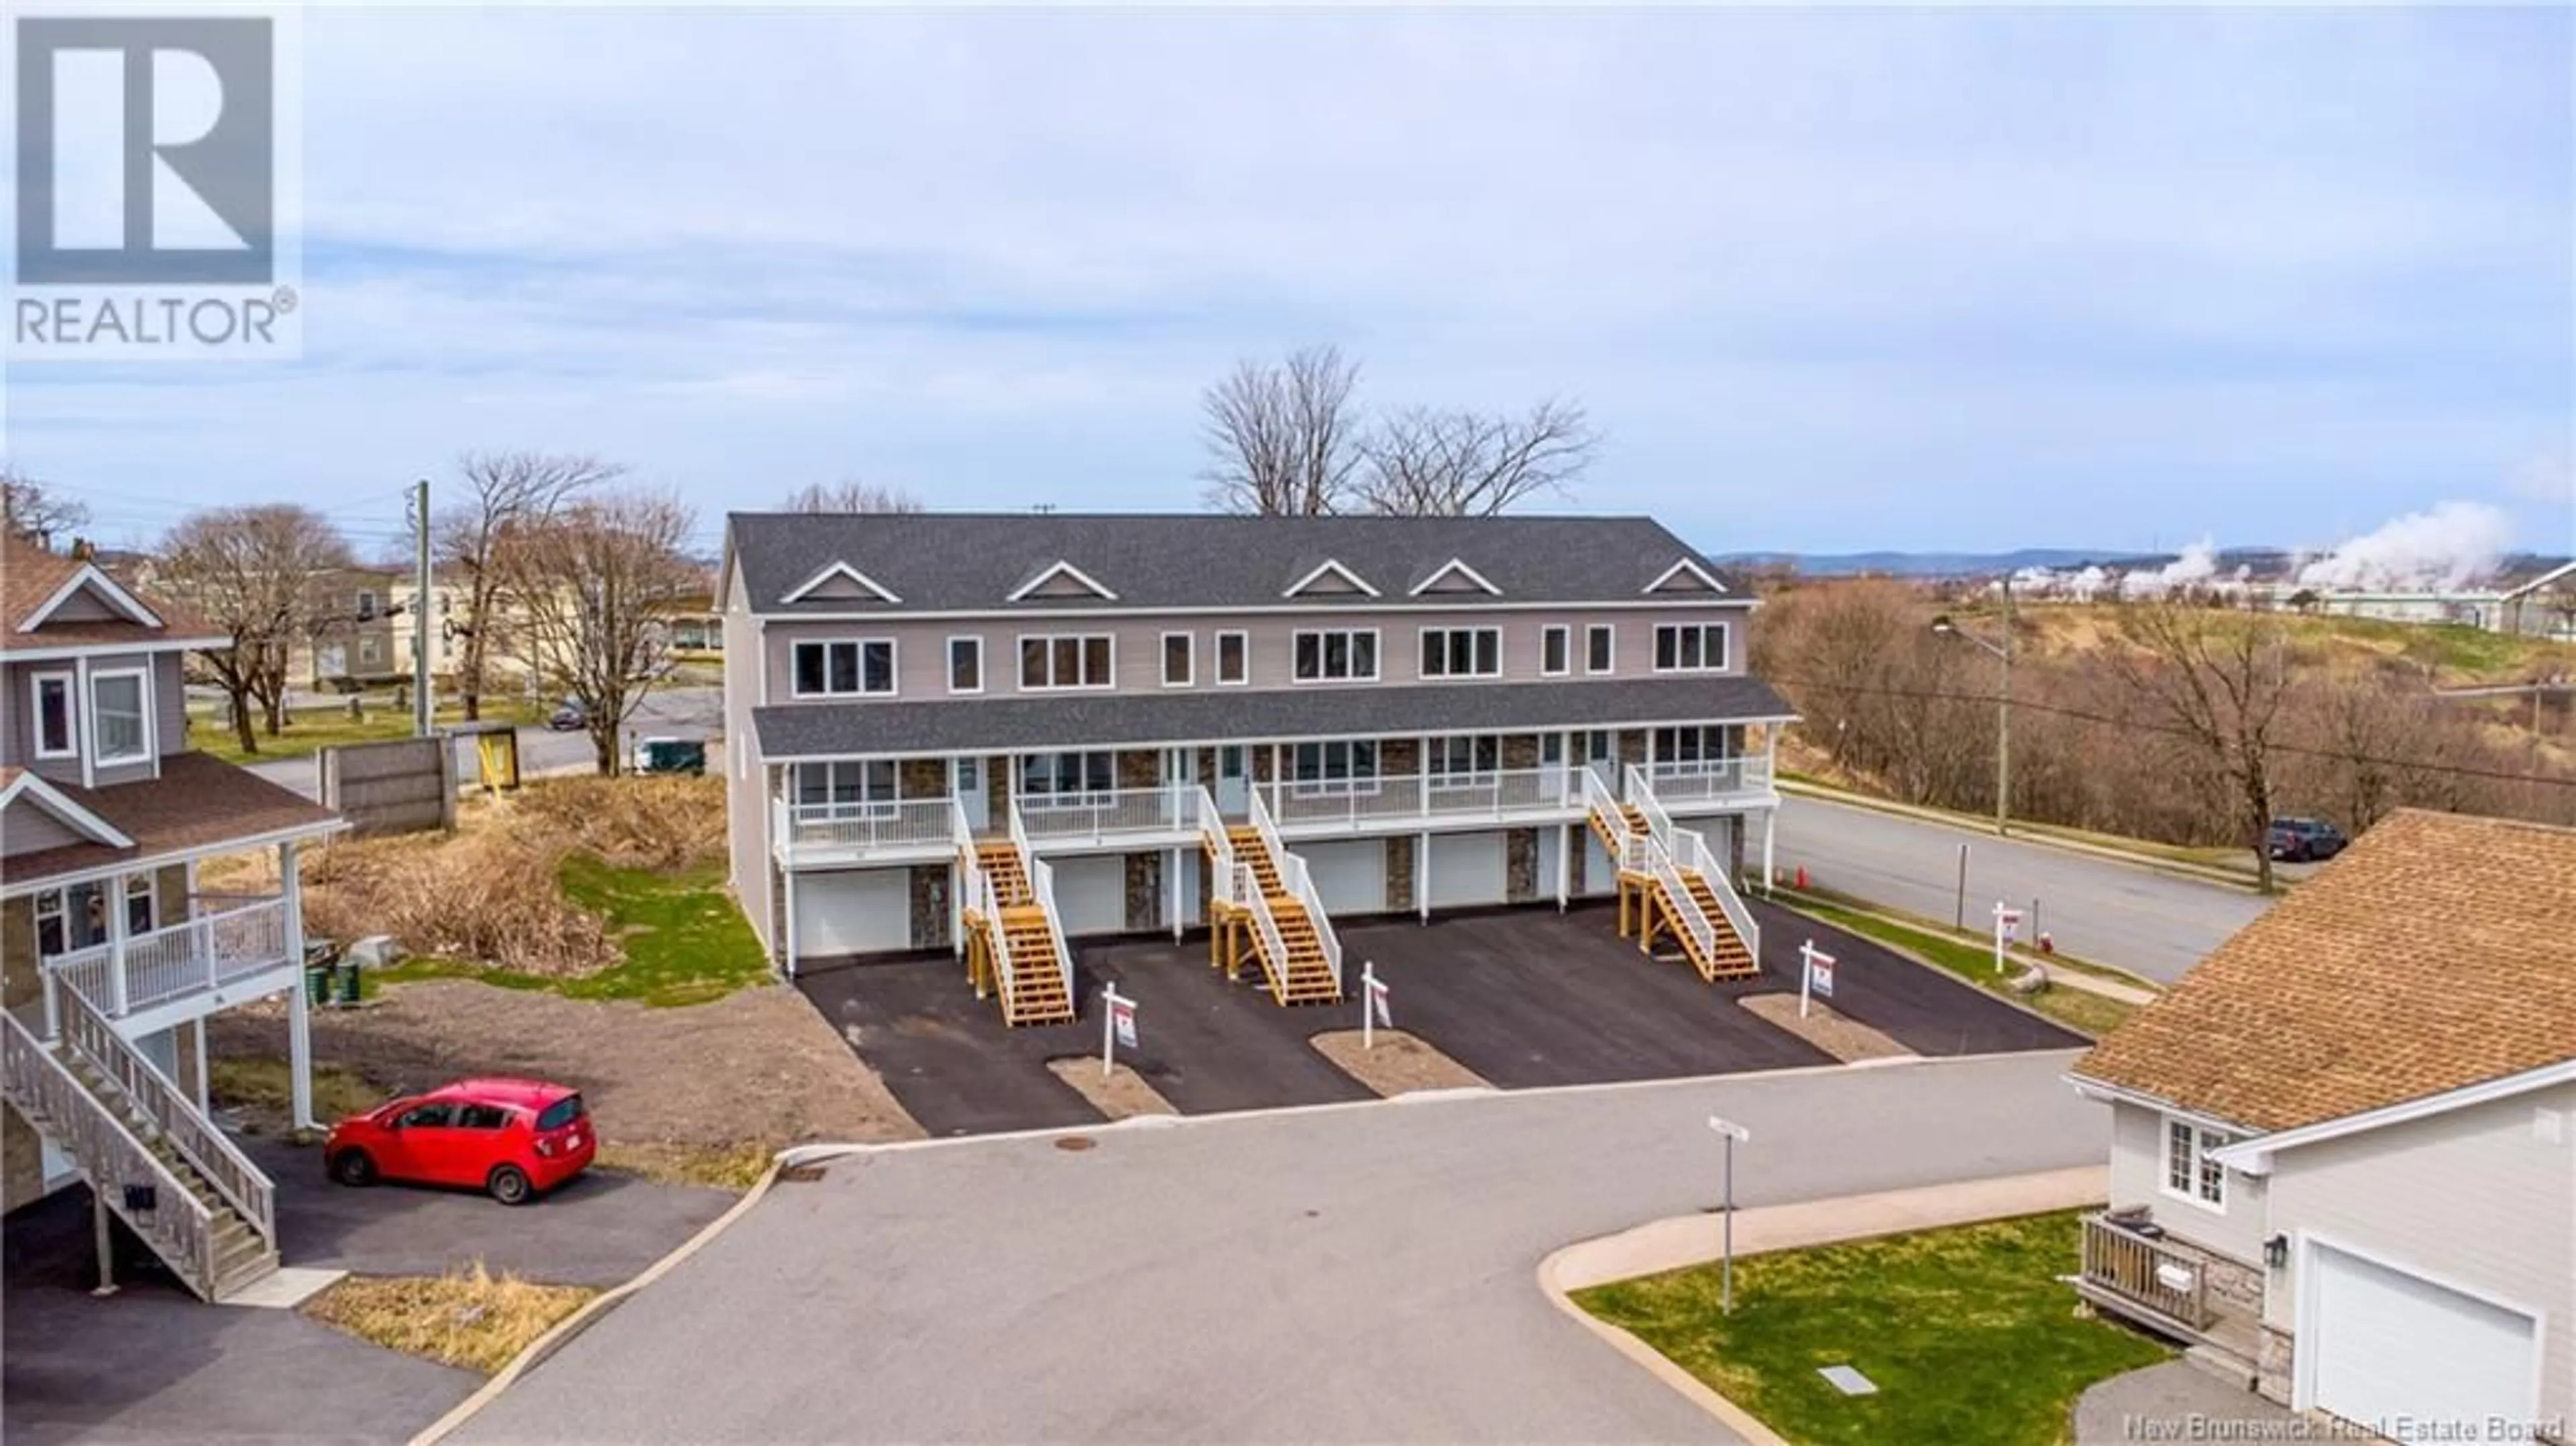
[1200,345,1360,518]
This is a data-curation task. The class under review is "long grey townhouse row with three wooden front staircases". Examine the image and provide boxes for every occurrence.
[718,513,1790,1021]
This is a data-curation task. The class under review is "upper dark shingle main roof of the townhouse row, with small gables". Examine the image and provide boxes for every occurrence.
[727,513,1752,616]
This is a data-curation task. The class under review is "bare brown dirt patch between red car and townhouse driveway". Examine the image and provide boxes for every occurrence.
[209,979,925,1147]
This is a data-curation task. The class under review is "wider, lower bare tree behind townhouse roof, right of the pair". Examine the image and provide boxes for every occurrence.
[1355,397,1600,518]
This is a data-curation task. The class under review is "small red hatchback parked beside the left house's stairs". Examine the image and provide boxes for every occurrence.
[322,1080,600,1204]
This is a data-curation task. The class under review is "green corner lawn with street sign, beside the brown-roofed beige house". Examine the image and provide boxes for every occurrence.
[1574,1214,2166,1446]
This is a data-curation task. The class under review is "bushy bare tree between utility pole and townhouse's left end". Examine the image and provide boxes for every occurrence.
[494,490,706,779]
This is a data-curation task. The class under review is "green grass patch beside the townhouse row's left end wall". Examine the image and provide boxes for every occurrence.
[363,853,770,1008]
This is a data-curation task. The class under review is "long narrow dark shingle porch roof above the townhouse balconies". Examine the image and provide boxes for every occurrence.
[752,678,1795,758]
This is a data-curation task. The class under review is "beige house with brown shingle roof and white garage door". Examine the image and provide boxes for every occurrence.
[2069,810,2576,1441]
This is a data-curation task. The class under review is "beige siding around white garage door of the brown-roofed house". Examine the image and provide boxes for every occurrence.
[2264,1085,2576,1421]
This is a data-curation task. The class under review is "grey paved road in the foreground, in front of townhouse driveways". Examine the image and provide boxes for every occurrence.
[456,1052,2107,1443]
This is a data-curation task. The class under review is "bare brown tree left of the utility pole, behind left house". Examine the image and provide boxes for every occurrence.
[160,502,350,753]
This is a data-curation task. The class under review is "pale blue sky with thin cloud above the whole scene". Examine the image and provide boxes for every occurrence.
[5,8,2576,551]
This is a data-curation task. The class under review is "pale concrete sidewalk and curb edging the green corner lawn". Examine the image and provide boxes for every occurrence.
[1538,1165,2110,1446]
